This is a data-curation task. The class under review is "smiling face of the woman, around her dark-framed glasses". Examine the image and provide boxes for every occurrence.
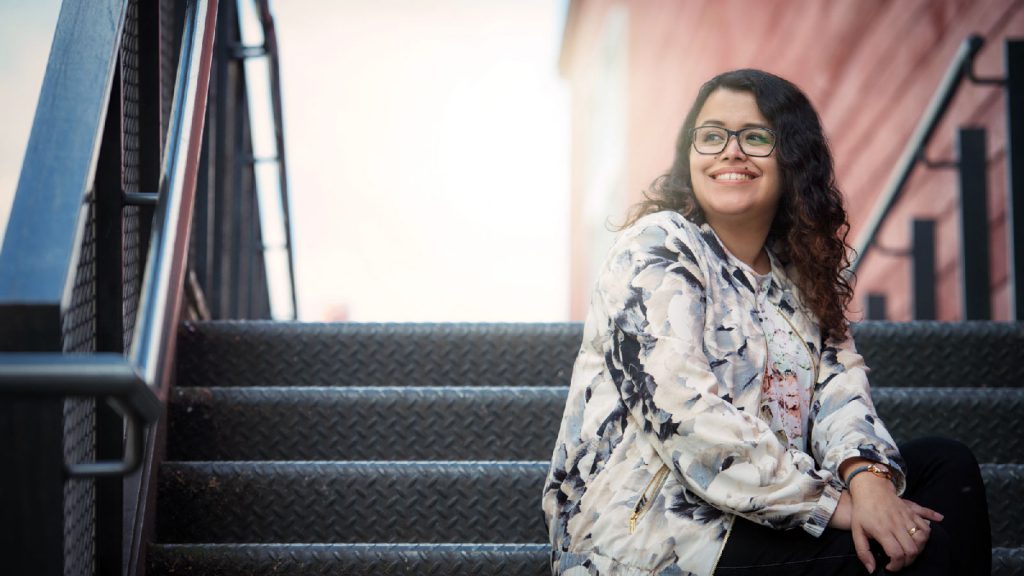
[690,88,780,228]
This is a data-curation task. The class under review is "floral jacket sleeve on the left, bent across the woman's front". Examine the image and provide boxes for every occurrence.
[593,220,841,536]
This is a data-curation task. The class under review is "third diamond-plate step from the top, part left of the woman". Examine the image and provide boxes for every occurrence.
[157,462,548,543]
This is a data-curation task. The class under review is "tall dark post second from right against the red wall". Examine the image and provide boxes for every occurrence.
[956,128,992,320]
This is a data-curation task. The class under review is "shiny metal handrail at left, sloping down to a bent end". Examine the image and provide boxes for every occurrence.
[0,0,217,477]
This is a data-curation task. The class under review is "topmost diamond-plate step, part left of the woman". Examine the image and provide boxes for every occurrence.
[178,321,583,386]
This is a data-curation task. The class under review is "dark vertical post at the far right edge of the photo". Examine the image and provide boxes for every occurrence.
[1006,40,1024,321]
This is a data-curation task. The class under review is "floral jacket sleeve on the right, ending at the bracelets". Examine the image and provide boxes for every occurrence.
[810,331,906,495]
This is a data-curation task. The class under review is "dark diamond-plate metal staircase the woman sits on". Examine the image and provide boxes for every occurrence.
[147,322,1024,575]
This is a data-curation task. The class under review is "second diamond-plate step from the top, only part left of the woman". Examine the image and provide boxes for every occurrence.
[168,386,567,460]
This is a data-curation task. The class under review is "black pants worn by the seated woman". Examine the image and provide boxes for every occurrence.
[715,438,992,576]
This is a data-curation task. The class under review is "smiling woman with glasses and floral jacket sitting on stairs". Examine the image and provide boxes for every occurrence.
[544,70,990,575]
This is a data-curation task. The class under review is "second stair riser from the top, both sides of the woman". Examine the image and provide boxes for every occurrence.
[168,387,1024,462]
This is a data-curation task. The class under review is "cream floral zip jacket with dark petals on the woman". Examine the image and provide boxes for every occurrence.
[543,212,904,576]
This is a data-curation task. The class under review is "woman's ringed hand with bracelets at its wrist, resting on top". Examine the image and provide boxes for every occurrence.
[834,474,942,572]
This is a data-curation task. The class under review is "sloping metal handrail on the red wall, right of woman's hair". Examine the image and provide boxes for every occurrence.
[850,35,985,273]
